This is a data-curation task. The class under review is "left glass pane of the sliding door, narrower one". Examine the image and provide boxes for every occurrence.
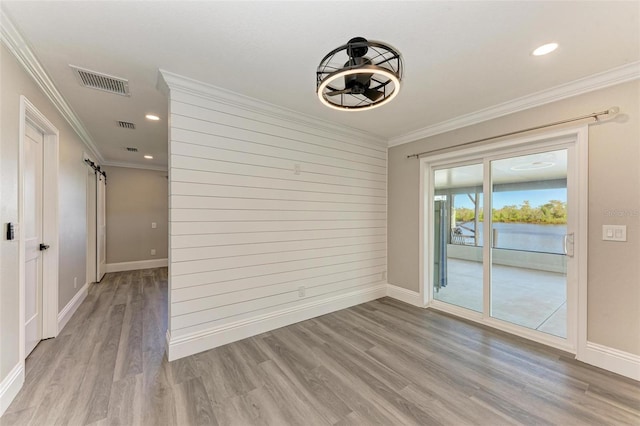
[433,164,483,312]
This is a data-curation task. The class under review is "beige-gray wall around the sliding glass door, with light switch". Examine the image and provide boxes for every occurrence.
[388,81,640,355]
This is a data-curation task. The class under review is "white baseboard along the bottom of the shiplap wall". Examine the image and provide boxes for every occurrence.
[167,284,387,361]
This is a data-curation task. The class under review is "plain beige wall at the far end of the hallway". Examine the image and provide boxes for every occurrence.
[104,167,169,264]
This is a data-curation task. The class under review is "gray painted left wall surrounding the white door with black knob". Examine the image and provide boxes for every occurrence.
[0,45,86,381]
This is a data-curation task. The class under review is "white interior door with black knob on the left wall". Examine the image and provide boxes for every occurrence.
[23,123,44,356]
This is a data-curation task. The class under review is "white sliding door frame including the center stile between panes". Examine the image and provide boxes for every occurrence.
[419,125,588,356]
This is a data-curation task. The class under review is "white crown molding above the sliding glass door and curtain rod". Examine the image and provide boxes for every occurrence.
[389,61,640,148]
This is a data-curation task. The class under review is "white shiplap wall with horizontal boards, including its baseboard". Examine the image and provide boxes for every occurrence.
[162,72,387,360]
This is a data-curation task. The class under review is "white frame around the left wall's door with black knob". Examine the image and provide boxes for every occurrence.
[18,96,60,362]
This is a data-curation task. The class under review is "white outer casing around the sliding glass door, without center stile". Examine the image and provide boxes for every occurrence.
[419,125,589,356]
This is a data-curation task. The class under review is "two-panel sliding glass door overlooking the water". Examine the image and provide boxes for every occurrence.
[425,138,577,347]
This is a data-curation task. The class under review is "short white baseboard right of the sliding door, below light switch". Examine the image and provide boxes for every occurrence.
[576,342,640,381]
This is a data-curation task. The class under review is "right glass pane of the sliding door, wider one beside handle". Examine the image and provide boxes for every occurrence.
[491,150,567,338]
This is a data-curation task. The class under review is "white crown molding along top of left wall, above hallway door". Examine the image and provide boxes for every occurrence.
[0,9,104,163]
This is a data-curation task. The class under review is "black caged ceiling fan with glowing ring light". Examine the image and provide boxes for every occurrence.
[316,37,403,110]
